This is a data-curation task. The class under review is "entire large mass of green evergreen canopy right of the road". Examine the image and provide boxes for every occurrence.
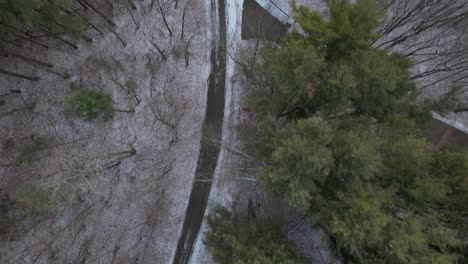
[245,0,468,263]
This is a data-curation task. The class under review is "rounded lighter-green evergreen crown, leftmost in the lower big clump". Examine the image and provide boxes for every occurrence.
[256,119,334,210]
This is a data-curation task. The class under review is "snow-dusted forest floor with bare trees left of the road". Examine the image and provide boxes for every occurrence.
[0,0,211,264]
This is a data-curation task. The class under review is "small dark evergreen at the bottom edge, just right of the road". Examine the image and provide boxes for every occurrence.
[204,208,304,264]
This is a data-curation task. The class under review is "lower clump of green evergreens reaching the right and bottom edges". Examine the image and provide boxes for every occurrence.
[257,118,468,263]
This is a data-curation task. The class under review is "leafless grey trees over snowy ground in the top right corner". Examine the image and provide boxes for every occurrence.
[374,0,468,89]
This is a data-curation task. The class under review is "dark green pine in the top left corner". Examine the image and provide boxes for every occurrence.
[0,0,84,81]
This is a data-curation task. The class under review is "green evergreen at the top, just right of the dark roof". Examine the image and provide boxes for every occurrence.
[250,0,416,120]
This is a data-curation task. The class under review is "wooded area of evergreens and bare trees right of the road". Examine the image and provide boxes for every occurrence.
[205,0,468,263]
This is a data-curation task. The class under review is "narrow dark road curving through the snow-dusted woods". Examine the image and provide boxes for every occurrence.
[173,0,226,264]
